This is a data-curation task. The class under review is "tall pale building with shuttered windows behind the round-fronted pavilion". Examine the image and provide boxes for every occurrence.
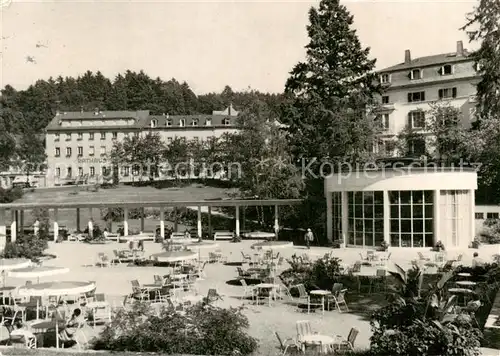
[377,41,480,155]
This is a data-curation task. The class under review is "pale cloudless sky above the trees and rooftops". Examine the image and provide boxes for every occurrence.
[0,0,477,94]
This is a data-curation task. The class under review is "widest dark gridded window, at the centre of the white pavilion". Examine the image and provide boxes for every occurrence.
[389,190,434,247]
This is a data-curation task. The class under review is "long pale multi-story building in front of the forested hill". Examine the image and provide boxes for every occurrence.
[46,106,238,185]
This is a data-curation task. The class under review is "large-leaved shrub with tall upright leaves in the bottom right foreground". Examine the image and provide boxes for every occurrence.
[370,266,482,356]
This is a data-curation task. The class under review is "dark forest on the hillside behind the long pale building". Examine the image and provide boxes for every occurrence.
[0,70,283,169]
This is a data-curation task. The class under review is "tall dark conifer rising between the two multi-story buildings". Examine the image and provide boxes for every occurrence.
[283,0,379,171]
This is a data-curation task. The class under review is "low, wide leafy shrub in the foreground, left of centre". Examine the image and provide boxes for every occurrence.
[91,303,258,355]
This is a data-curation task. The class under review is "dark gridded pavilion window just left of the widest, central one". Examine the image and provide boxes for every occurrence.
[347,191,384,246]
